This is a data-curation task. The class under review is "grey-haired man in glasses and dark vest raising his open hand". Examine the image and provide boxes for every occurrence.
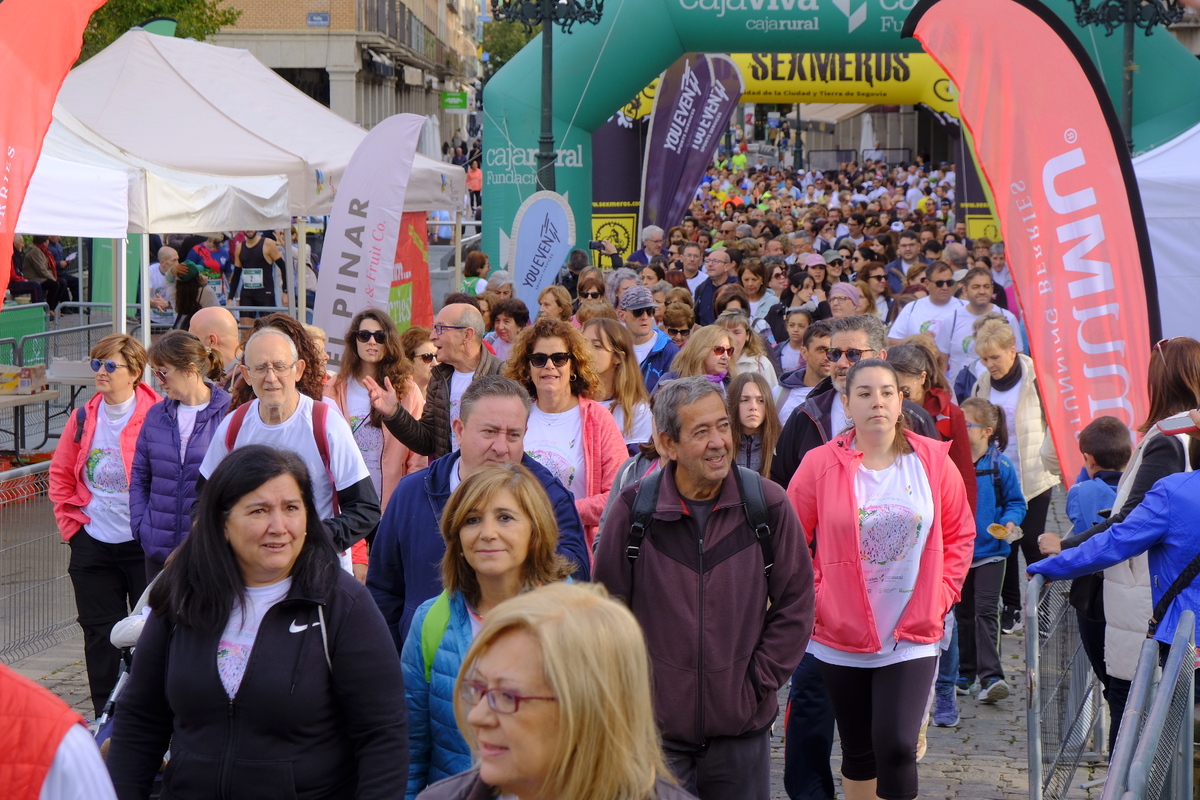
[376,302,504,461]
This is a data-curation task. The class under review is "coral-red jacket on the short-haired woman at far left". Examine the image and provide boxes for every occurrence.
[48,383,162,542]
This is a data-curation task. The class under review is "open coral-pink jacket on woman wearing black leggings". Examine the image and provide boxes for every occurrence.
[787,431,976,652]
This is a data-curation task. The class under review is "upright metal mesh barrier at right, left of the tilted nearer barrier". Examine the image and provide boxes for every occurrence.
[1025,576,1106,800]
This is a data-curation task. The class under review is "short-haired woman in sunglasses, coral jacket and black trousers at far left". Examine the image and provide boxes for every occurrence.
[48,333,162,717]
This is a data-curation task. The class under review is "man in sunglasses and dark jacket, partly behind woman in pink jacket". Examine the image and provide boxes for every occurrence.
[770,315,940,798]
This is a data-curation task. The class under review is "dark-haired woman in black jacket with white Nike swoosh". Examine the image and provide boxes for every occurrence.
[108,445,408,800]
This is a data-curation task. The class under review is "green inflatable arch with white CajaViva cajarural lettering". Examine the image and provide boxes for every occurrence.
[482,0,1200,255]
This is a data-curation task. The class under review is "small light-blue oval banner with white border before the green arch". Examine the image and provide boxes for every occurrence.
[511,192,575,318]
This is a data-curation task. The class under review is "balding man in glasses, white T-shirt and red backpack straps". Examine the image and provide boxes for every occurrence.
[196,327,379,561]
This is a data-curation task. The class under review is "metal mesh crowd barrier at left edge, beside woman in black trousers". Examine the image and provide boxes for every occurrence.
[0,463,79,664]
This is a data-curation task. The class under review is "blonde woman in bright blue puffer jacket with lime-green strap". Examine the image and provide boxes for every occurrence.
[401,464,574,799]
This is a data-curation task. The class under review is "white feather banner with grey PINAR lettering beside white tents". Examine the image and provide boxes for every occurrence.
[313,114,425,368]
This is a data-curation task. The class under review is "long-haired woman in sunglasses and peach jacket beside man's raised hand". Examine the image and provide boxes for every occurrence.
[325,308,428,525]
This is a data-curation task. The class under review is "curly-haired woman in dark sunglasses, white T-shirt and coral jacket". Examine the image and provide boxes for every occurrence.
[504,319,636,548]
